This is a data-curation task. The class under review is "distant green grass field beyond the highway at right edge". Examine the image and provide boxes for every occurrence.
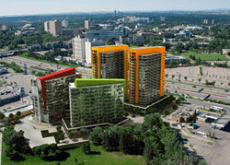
[182,51,230,61]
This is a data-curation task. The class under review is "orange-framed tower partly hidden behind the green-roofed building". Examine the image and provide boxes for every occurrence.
[92,45,128,97]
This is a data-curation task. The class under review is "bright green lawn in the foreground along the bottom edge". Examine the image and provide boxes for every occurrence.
[2,143,146,165]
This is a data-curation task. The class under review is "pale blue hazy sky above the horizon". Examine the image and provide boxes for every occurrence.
[0,0,230,16]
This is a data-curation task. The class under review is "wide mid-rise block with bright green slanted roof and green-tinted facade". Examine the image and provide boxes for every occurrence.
[69,78,126,127]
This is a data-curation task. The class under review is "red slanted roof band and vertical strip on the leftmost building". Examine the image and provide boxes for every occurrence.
[38,68,76,110]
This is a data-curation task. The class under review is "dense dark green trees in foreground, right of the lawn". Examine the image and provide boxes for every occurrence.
[89,113,206,165]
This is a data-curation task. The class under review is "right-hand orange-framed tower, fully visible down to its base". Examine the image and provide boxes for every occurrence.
[127,47,165,105]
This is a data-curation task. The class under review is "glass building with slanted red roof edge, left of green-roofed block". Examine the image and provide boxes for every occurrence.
[31,68,82,124]
